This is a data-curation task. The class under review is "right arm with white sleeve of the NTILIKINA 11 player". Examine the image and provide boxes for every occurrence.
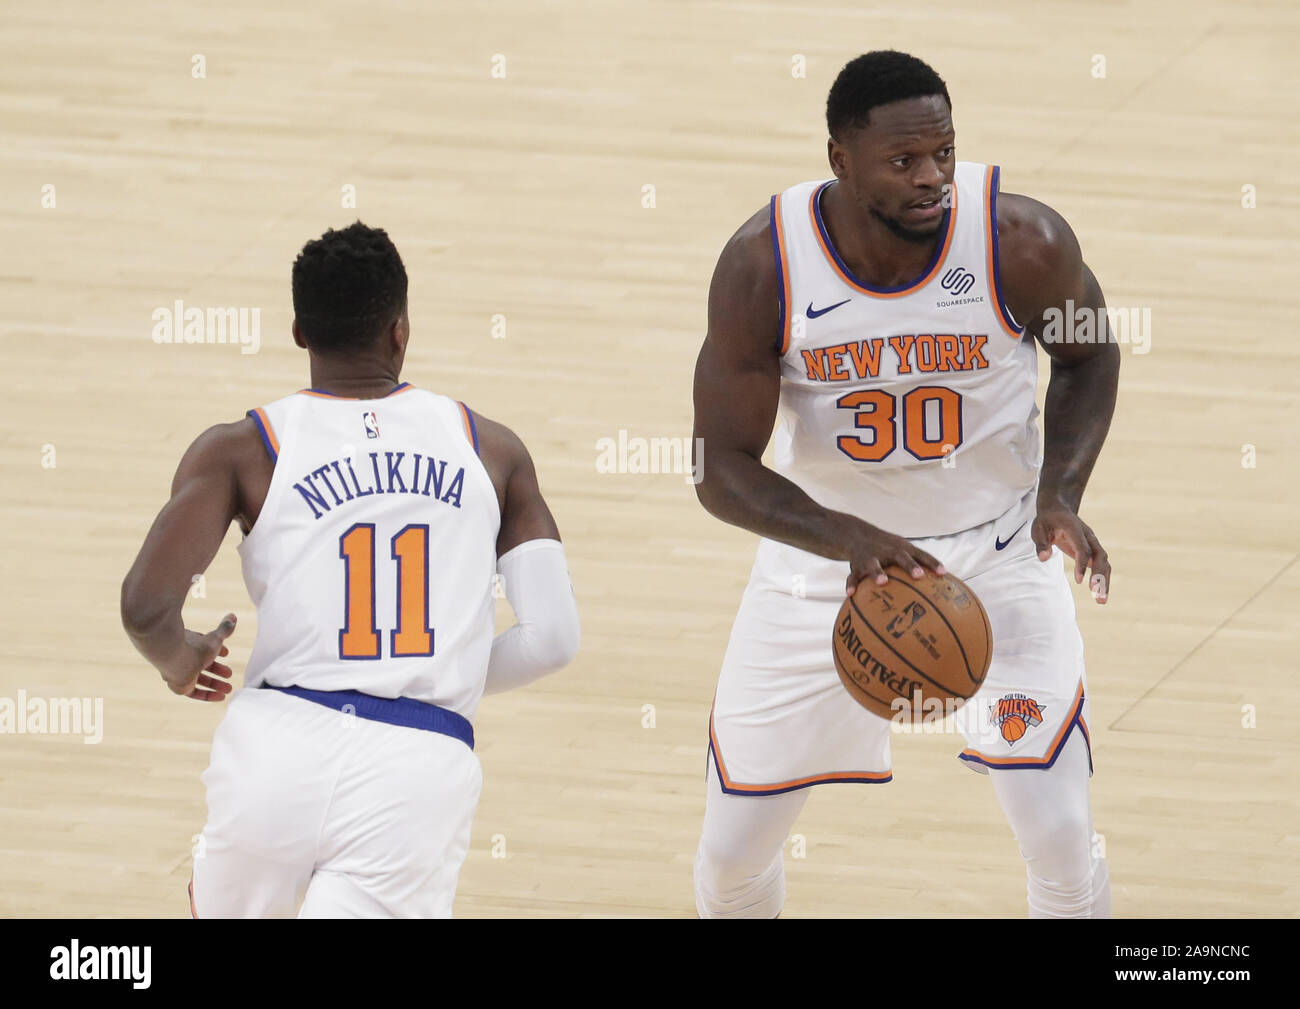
[475,413,581,693]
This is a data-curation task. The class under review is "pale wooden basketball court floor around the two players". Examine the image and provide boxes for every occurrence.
[0,0,1300,917]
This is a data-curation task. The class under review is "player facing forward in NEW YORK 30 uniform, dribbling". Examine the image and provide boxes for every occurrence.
[694,52,1119,918]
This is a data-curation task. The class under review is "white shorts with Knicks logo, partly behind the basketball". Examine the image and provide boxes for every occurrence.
[710,490,1091,796]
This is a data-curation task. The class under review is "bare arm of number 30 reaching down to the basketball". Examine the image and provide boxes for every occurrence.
[692,209,944,594]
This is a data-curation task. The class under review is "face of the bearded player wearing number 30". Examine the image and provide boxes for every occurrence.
[829,95,957,242]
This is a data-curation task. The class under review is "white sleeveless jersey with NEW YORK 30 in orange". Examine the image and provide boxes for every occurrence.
[771,161,1041,538]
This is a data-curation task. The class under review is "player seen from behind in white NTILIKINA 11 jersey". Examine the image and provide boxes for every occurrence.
[122,222,579,918]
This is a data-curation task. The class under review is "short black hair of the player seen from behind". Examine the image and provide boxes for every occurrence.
[293,221,407,354]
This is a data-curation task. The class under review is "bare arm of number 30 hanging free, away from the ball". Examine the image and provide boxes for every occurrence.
[997,194,1119,603]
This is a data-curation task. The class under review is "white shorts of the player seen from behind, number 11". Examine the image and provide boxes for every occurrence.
[191,688,482,918]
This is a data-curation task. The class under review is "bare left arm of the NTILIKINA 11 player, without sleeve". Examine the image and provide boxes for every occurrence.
[121,420,260,701]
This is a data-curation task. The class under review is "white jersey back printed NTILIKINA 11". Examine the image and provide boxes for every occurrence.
[239,384,501,719]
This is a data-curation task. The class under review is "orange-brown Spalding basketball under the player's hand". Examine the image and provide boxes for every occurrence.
[832,564,993,720]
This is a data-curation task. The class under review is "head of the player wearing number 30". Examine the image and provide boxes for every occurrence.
[826,49,957,242]
